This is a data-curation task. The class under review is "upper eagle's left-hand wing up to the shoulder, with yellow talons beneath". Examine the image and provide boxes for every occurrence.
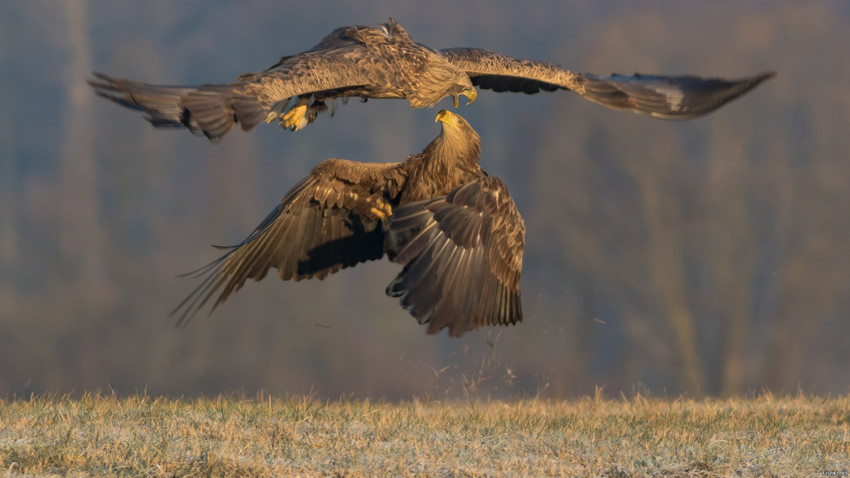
[89,27,414,142]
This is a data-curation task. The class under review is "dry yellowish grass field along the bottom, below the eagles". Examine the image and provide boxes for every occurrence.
[0,394,850,476]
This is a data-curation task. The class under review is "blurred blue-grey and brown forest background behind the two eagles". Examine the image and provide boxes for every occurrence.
[0,0,850,399]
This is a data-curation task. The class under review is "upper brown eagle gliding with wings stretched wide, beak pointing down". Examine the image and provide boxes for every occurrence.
[89,19,773,142]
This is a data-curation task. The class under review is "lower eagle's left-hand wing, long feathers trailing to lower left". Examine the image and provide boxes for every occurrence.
[172,159,405,325]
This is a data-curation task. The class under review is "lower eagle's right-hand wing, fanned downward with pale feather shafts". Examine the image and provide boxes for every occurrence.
[387,177,525,337]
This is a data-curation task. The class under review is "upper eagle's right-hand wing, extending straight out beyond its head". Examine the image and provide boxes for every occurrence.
[440,48,774,119]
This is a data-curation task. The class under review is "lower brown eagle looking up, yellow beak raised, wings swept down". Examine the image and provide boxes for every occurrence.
[173,110,525,337]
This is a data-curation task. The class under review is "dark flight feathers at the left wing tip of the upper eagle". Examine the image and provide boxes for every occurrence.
[89,73,266,142]
